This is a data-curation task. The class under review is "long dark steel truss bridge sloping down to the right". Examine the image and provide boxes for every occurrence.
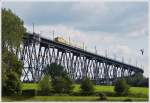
[17,33,144,84]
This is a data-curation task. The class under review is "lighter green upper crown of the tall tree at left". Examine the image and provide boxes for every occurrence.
[2,8,26,49]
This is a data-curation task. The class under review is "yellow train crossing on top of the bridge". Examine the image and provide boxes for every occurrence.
[54,37,84,49]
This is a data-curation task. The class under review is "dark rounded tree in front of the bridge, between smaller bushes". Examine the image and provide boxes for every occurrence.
[44,63,73,93]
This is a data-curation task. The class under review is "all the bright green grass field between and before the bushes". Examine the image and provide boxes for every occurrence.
[2,83,149,102]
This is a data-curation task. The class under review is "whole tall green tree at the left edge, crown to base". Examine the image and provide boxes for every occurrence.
[2,8,26,95]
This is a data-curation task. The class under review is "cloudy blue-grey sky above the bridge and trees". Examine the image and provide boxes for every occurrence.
[2,1,148,76]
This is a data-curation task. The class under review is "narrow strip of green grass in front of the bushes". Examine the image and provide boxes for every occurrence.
[2,96,148,102]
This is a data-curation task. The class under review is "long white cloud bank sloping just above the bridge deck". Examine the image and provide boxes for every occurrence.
[26,22,148,75]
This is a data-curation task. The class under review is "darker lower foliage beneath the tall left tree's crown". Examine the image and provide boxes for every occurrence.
[2,49,23,95]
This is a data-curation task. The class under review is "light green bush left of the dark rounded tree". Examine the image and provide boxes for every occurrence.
[38,75,52,95]
